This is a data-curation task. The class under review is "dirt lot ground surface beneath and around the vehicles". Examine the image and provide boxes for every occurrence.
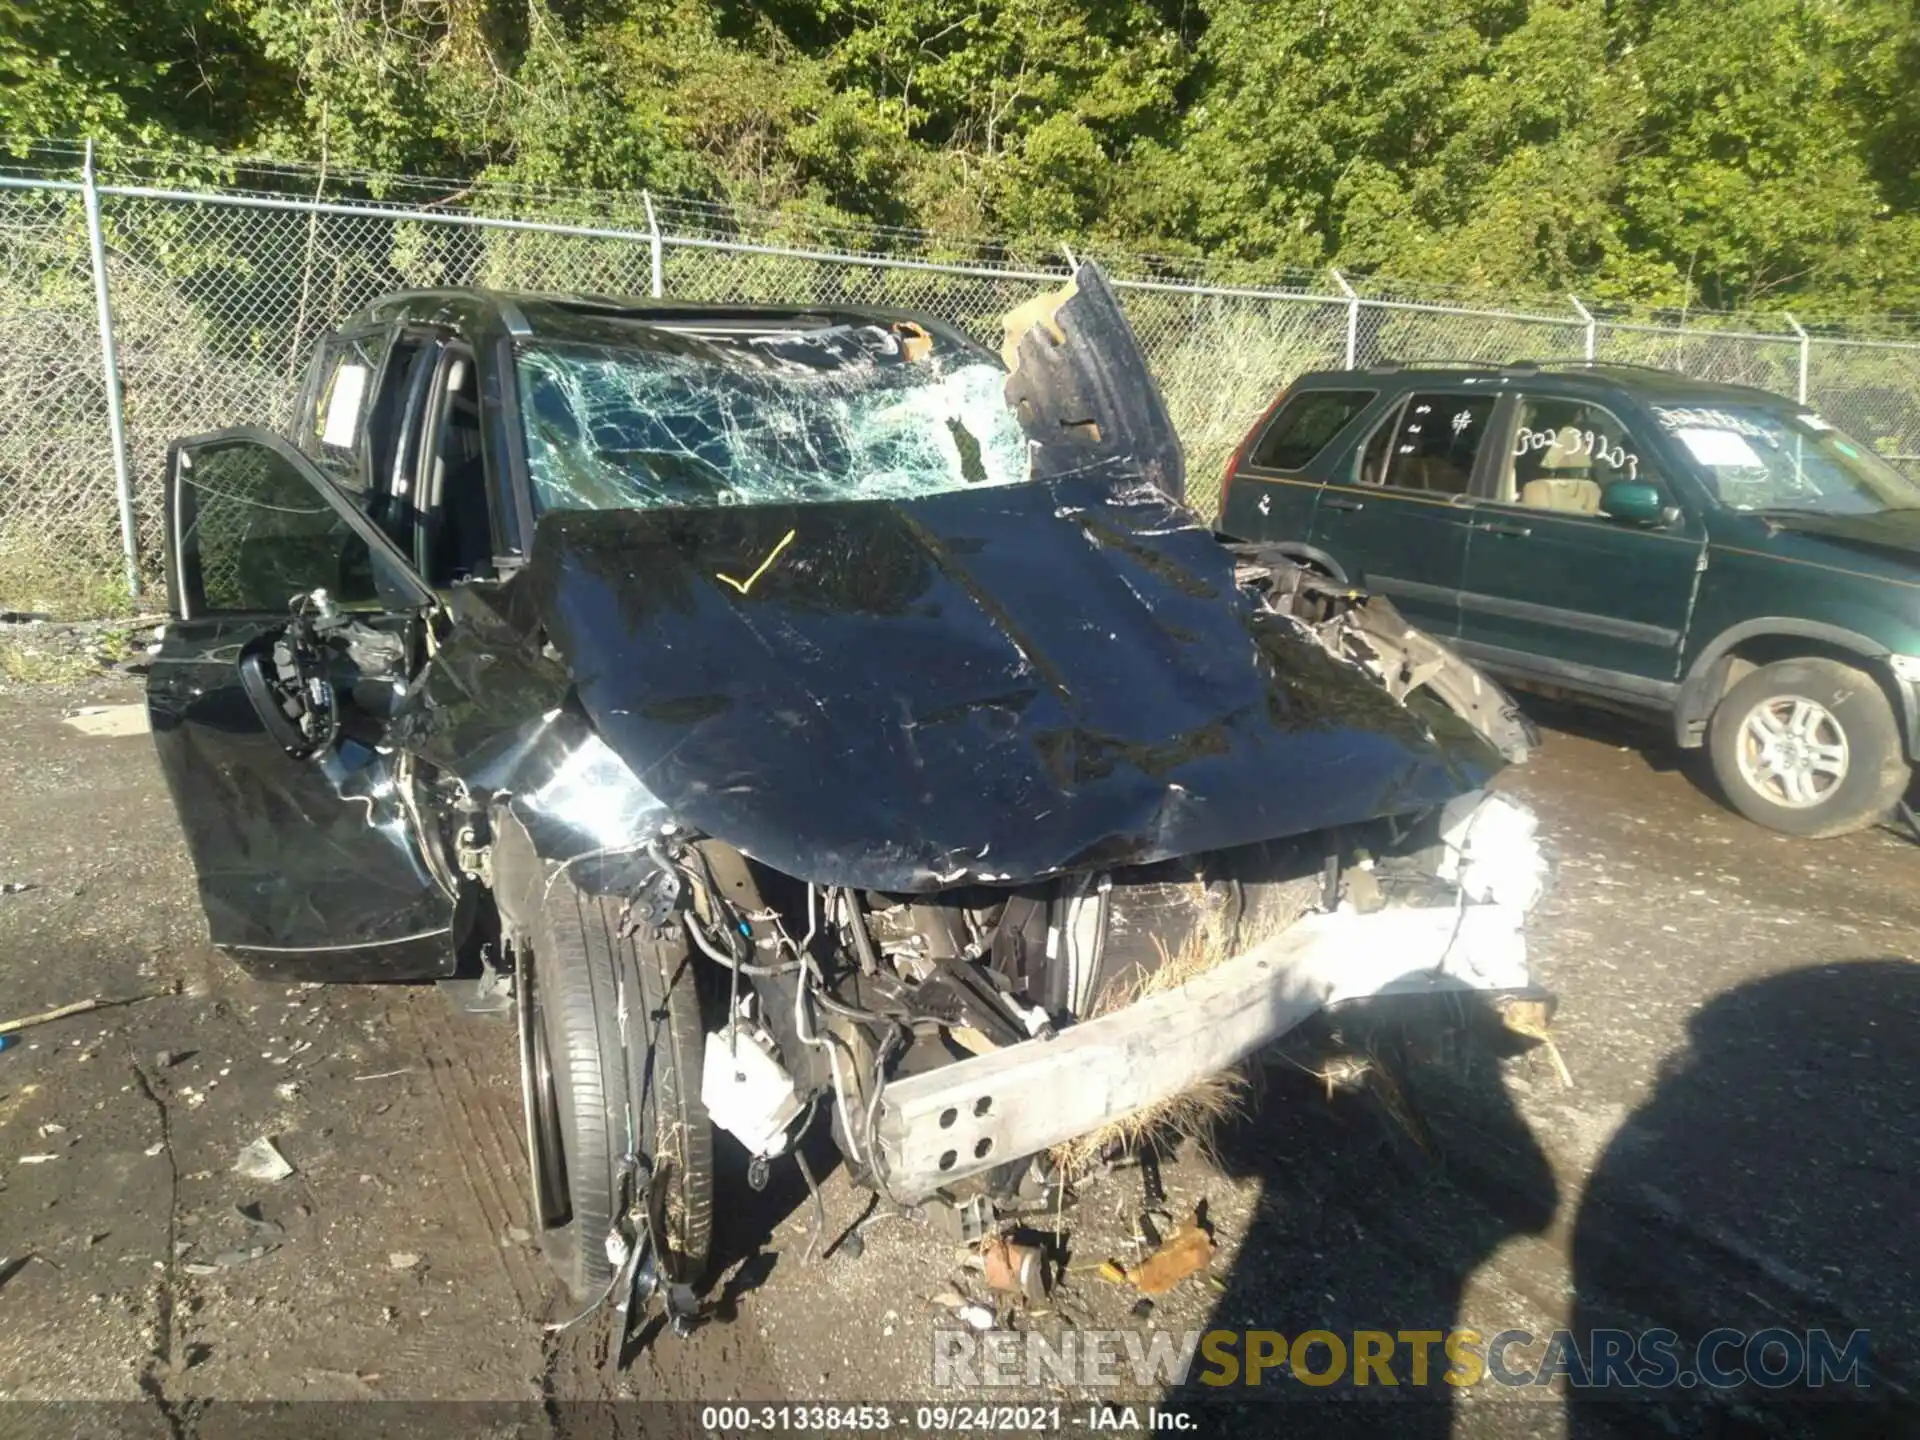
[0,678,1920,1436]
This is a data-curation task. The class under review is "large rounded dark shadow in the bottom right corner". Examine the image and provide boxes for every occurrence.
[1569,960,1920,1438]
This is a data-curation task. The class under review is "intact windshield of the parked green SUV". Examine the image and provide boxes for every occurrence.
[1653,405,1920,515]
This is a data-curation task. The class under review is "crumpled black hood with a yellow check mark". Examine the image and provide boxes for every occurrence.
[515,465,1500,891]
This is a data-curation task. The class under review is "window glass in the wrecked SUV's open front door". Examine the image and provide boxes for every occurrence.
[175,440,407,614]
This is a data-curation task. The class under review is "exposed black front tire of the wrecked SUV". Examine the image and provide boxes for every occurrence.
[528,877,712,1302]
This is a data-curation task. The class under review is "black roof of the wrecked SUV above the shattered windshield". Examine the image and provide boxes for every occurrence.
[346,288,979,349]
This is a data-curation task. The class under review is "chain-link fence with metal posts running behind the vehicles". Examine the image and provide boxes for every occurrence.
[0,162,1920,609]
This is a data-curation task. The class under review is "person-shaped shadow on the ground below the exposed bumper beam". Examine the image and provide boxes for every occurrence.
[1165,996,1559,1440]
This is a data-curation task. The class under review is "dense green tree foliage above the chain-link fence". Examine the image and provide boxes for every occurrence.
[0,0,1920,311]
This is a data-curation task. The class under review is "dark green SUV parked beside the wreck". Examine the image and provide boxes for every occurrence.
[1219,363,1920,837]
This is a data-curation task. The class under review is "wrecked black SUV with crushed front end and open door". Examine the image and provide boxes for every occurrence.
[150,267,1540,1328]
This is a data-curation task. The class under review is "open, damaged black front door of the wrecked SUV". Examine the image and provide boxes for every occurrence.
[148,430,455,979]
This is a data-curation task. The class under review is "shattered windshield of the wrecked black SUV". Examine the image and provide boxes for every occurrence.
[518,324,1029,513]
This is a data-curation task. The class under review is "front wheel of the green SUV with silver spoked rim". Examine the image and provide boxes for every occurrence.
[1707,659,1908,839]
